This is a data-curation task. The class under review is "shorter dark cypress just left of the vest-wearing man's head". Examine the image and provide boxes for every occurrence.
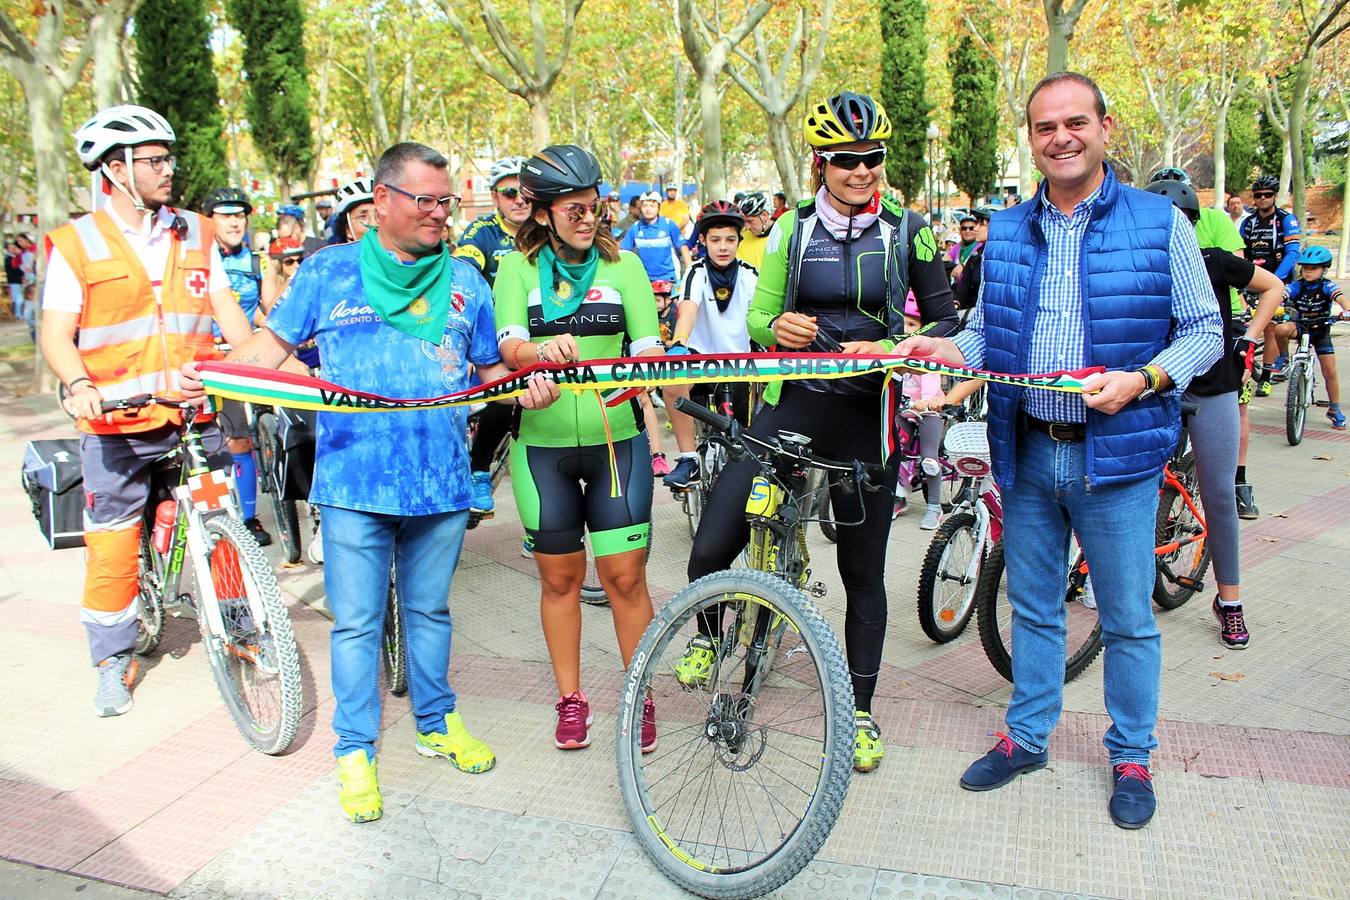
[946,29,999,204]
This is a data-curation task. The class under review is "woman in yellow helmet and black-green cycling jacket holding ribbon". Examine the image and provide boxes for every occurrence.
[680,92,956,772]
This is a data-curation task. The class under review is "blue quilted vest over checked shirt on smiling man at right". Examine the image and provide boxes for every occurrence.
[983,166,1181,490]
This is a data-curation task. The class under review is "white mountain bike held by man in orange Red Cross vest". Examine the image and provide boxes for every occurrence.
[103,394,304,754]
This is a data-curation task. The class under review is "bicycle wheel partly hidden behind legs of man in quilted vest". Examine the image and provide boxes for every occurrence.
[975,541,1102,683]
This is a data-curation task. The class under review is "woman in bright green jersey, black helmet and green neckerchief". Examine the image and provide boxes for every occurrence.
[493,144,664,753]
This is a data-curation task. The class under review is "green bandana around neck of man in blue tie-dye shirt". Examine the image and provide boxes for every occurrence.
[360,228,454,347]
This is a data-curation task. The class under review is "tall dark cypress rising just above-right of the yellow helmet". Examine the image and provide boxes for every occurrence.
[878,0,932,201]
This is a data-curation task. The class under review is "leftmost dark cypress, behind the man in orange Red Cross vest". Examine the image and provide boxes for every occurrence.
[135,0,230,208]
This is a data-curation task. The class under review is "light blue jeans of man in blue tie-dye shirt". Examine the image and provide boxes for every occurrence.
[320,506,468,760]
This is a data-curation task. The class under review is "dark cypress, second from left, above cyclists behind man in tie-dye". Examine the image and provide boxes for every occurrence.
[225,0,313,185]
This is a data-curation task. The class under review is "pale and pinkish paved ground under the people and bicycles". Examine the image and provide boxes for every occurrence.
[0,325,1350,899]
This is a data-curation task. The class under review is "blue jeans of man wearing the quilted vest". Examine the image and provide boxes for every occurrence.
[1003,432,1162,765]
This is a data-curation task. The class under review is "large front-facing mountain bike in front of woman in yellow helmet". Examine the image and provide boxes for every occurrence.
[617,398,888,897]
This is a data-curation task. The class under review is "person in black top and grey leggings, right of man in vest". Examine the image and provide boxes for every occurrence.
[1145,179,1284,650]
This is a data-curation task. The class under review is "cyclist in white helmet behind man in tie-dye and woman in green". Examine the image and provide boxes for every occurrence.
[455,157,529,518]
